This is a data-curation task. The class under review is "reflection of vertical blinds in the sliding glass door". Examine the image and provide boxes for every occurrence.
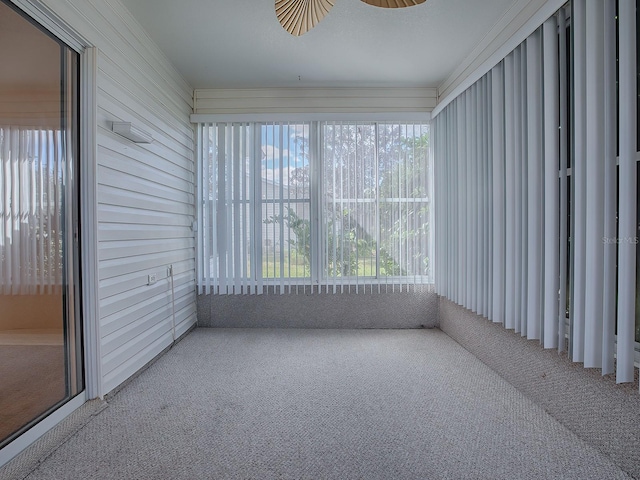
[0,126,66,295]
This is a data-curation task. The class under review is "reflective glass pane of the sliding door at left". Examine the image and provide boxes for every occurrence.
[0,0,84,447]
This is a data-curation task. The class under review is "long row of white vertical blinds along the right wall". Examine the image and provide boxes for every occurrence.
[432,0,638,382]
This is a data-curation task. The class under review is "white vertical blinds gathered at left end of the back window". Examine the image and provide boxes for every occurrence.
[197,123,262,294]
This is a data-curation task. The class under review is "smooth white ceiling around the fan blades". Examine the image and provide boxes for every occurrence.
[122,0,517,88]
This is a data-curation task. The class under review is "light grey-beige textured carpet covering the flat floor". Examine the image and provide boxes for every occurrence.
[0,329,630,480]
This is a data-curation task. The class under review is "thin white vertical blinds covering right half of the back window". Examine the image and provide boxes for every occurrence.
[320,122,431,291]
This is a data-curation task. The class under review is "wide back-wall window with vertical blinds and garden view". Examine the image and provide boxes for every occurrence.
[198,122,431,294]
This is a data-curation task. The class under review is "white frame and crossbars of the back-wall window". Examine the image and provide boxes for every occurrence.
[195,118,434,294]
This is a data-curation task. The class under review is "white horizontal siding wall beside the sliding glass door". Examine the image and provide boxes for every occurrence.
[43,0,196,395]
